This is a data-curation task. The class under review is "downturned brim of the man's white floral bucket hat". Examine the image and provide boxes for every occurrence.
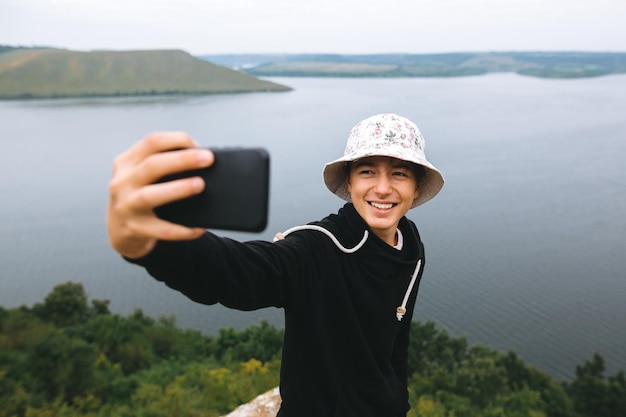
[323,155,445,208]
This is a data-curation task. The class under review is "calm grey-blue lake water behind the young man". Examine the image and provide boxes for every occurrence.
[0,74,626,378]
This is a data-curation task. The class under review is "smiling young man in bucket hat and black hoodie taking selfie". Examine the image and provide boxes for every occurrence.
[107,114,444,417]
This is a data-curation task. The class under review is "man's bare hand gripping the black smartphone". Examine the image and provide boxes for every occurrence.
[106,132,214,258]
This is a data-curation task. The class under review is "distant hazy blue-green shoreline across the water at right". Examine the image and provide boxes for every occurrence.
[200,52,626,78]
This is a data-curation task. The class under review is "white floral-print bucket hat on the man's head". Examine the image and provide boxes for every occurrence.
[324,114,444,208]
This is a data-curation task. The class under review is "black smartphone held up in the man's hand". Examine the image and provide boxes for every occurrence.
[154,148,270,232]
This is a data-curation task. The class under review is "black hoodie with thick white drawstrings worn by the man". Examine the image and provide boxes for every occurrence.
[133,203,424,417]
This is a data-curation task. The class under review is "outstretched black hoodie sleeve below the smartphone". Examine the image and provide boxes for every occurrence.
[127,232,295,310]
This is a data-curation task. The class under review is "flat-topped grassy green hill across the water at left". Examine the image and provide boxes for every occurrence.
[0,48,290,99]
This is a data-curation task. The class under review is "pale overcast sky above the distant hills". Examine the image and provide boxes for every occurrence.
[0,0,626,55]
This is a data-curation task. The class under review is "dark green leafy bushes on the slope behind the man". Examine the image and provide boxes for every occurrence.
[0,282,626,417]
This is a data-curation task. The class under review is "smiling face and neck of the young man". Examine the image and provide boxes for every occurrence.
[346,156,418,246]
